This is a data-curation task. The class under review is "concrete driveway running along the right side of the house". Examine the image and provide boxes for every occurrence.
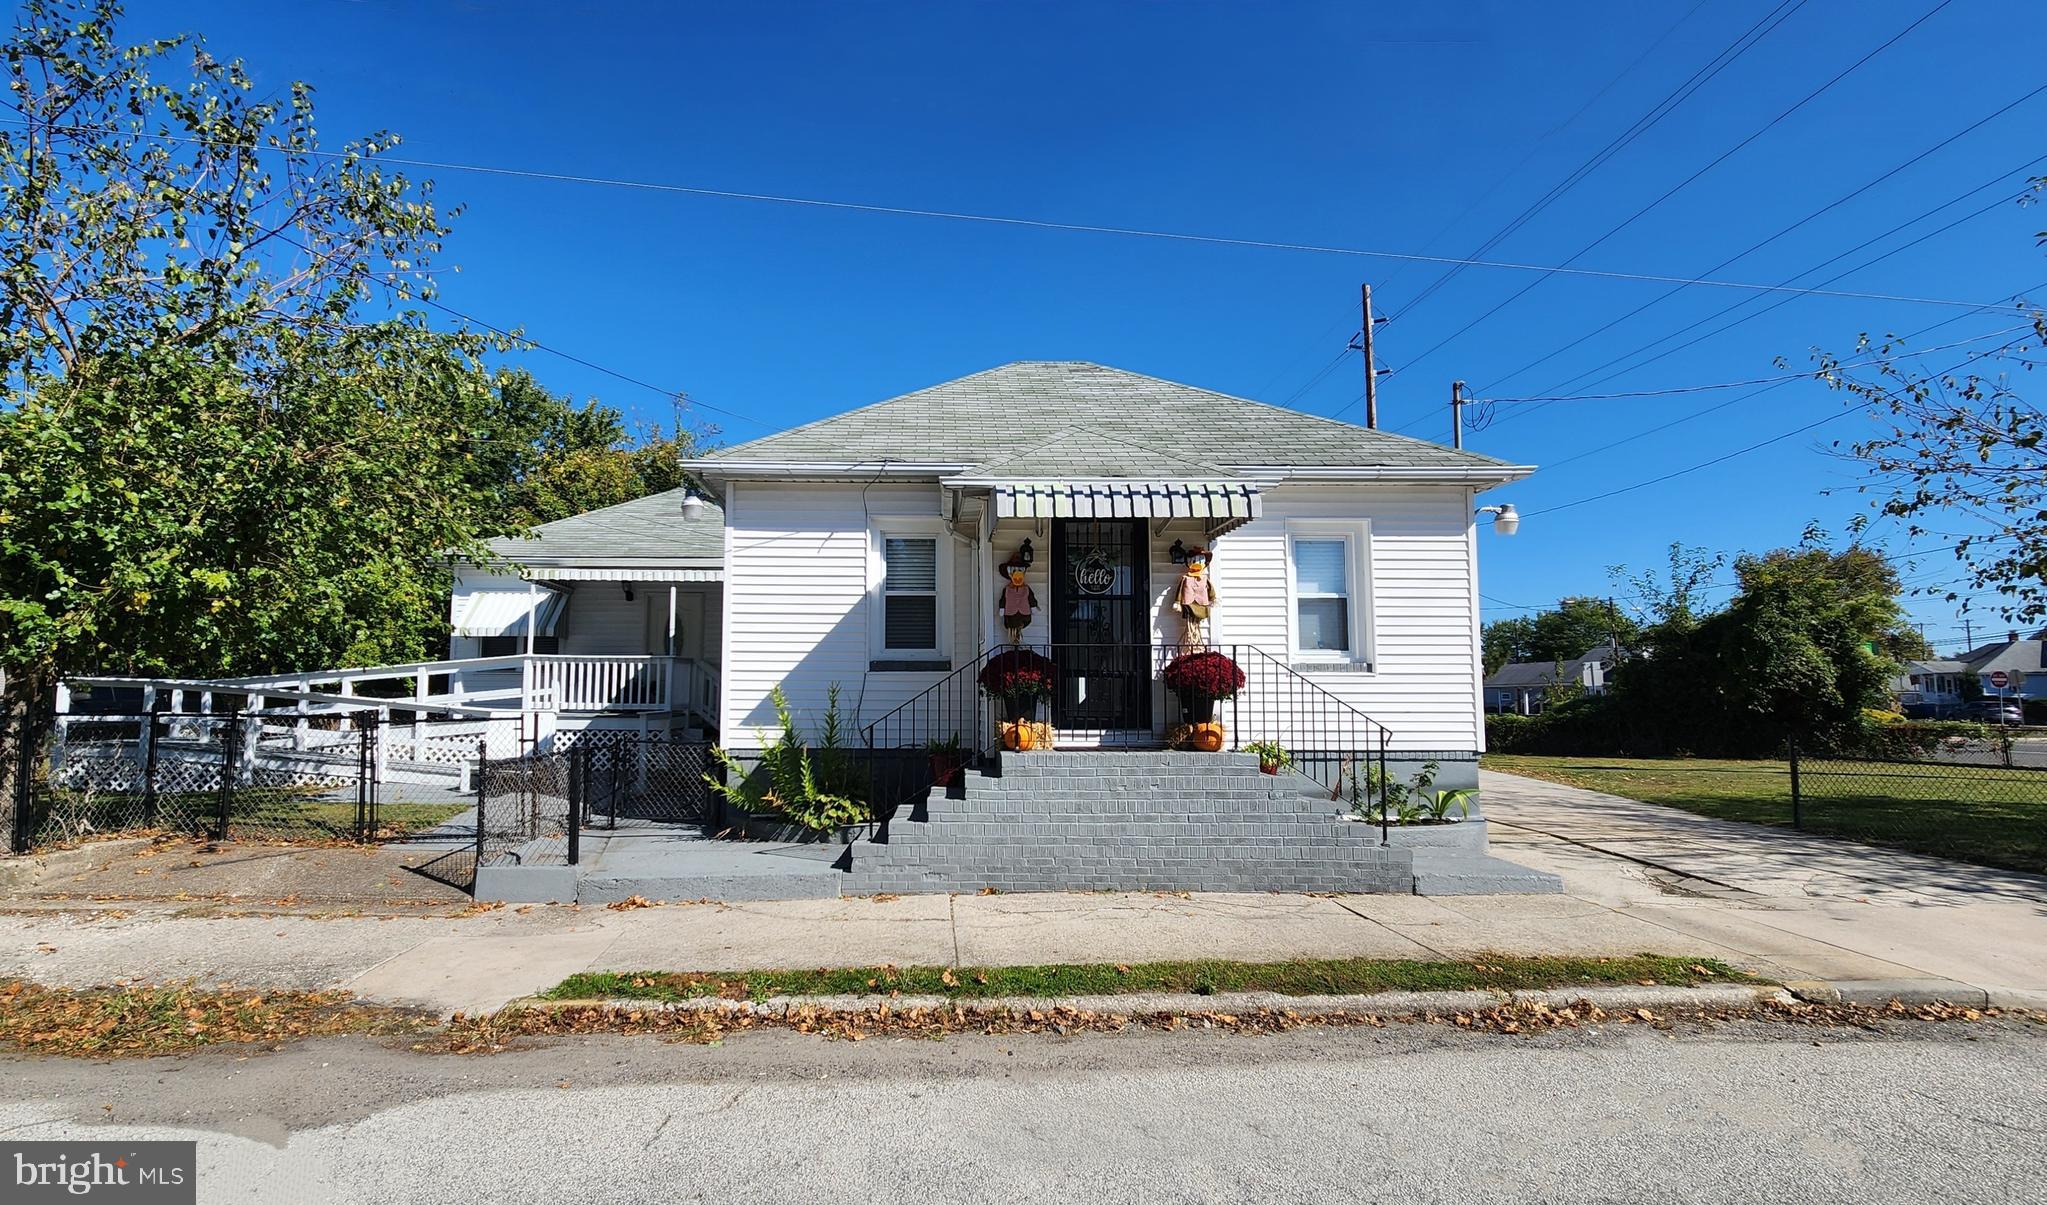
[1480,771,2047,1002]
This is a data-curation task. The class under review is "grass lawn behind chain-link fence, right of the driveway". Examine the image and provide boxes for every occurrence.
[1484,753,2047,874]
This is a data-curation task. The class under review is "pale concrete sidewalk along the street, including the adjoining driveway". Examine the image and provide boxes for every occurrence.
[0,773,2047,1013]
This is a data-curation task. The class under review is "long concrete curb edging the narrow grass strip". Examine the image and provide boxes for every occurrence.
[548,984,1793,1017]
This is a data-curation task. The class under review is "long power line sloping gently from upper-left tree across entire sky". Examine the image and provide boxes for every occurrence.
[0,114,2014,309]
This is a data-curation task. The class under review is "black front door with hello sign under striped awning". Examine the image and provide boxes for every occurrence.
[1050,520,1150,732]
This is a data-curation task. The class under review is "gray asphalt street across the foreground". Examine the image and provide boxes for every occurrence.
[0,1021,2047,1205]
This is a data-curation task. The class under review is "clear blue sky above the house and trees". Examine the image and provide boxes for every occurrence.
[131,0,2047,646]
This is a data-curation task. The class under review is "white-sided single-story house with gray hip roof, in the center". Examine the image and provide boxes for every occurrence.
[688,362,1531,759]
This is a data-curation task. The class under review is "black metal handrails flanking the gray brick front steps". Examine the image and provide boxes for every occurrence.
[862,642,1392,839]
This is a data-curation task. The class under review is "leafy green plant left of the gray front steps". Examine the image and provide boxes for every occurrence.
[704,683,874,833]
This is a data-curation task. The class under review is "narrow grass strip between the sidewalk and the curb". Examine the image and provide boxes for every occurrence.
[542,953,1762,1000]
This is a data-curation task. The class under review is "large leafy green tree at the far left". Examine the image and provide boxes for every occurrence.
[0,0,502,732]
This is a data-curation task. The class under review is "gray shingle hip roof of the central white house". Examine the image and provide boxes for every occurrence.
[710,360,1507,477]
